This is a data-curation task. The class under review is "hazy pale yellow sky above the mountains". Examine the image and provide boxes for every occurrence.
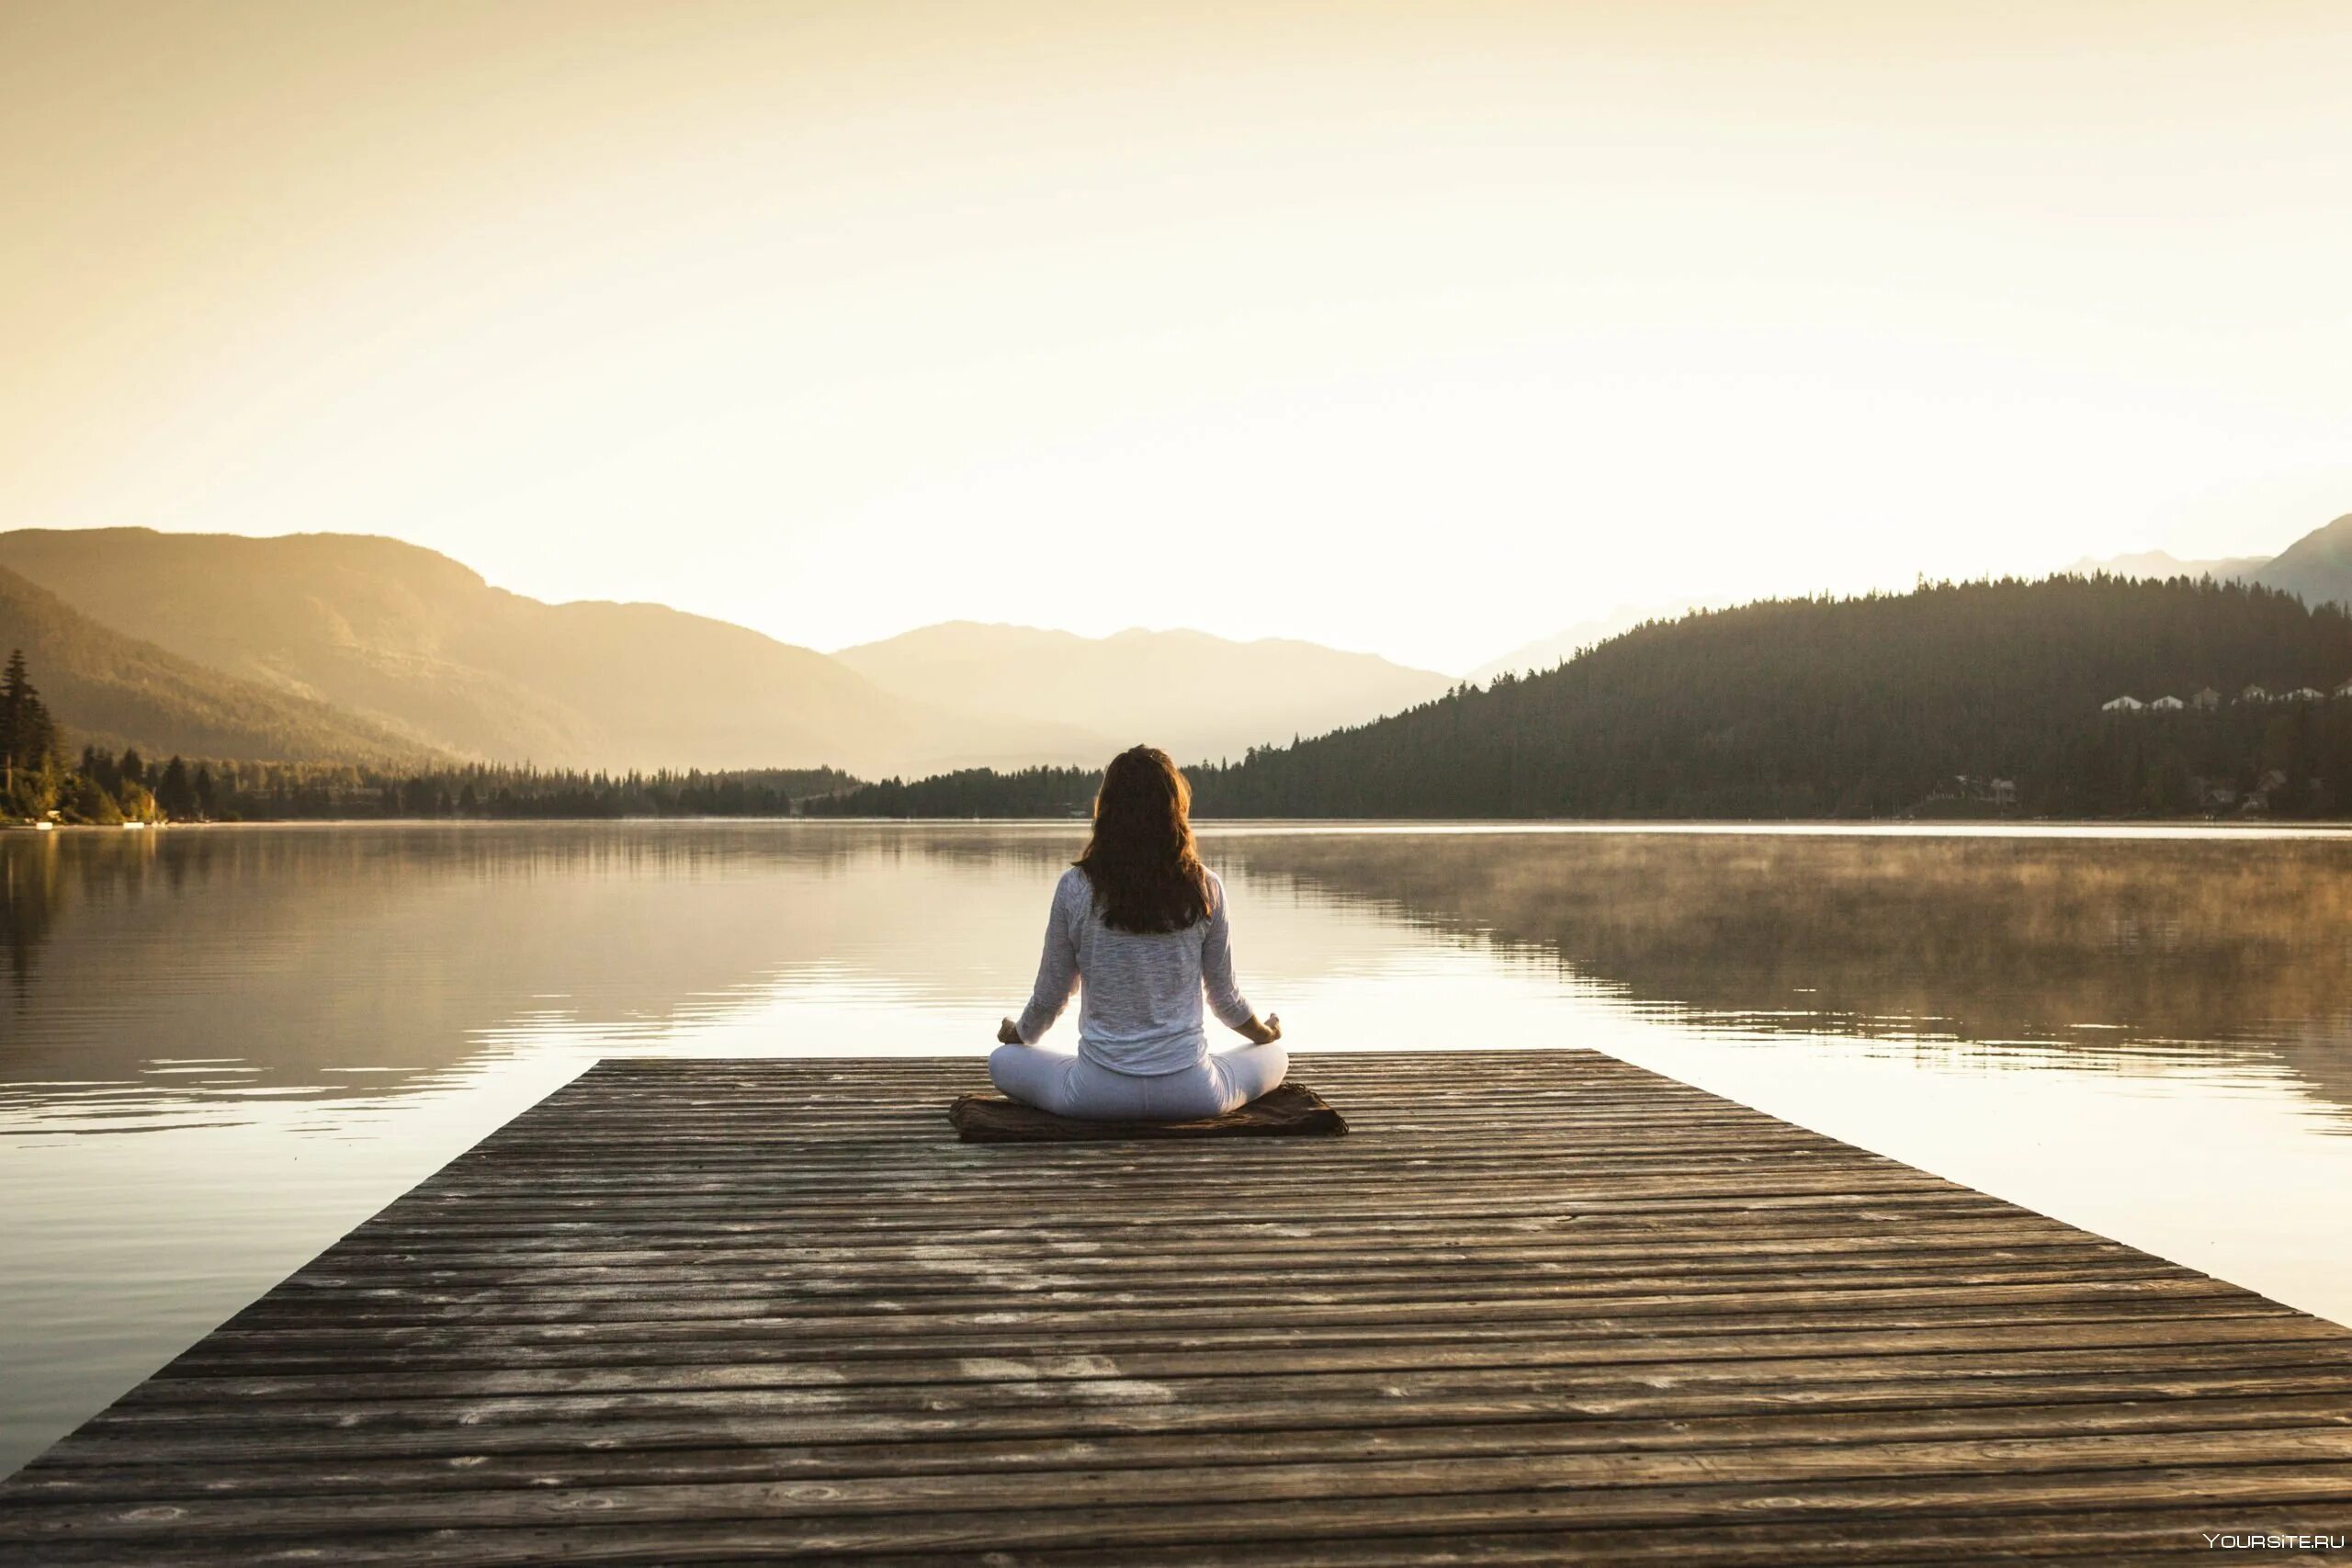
[0,0,2352,670]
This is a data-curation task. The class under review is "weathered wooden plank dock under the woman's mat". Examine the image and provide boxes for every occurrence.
[0,1051,2352,1568]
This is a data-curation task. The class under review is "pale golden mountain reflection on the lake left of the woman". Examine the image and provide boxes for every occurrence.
[0,825,1066,1131]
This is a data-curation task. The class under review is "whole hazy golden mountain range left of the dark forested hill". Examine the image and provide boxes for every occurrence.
[0,529,1449,776]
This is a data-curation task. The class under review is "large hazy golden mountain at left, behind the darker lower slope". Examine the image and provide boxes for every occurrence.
[0,529,1110,769]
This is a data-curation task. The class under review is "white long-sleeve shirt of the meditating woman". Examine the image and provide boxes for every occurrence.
[1016,865,1251,1075]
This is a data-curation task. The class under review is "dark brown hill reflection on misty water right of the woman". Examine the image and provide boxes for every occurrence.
[1226,832,2352,1110]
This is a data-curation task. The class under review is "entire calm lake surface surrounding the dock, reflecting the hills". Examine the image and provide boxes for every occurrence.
[0,823,2352,1472]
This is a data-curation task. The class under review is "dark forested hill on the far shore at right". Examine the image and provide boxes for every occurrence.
[818,576,2352,818]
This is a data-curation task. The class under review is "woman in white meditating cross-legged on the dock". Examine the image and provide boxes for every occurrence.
[988,745,1289,1122]
